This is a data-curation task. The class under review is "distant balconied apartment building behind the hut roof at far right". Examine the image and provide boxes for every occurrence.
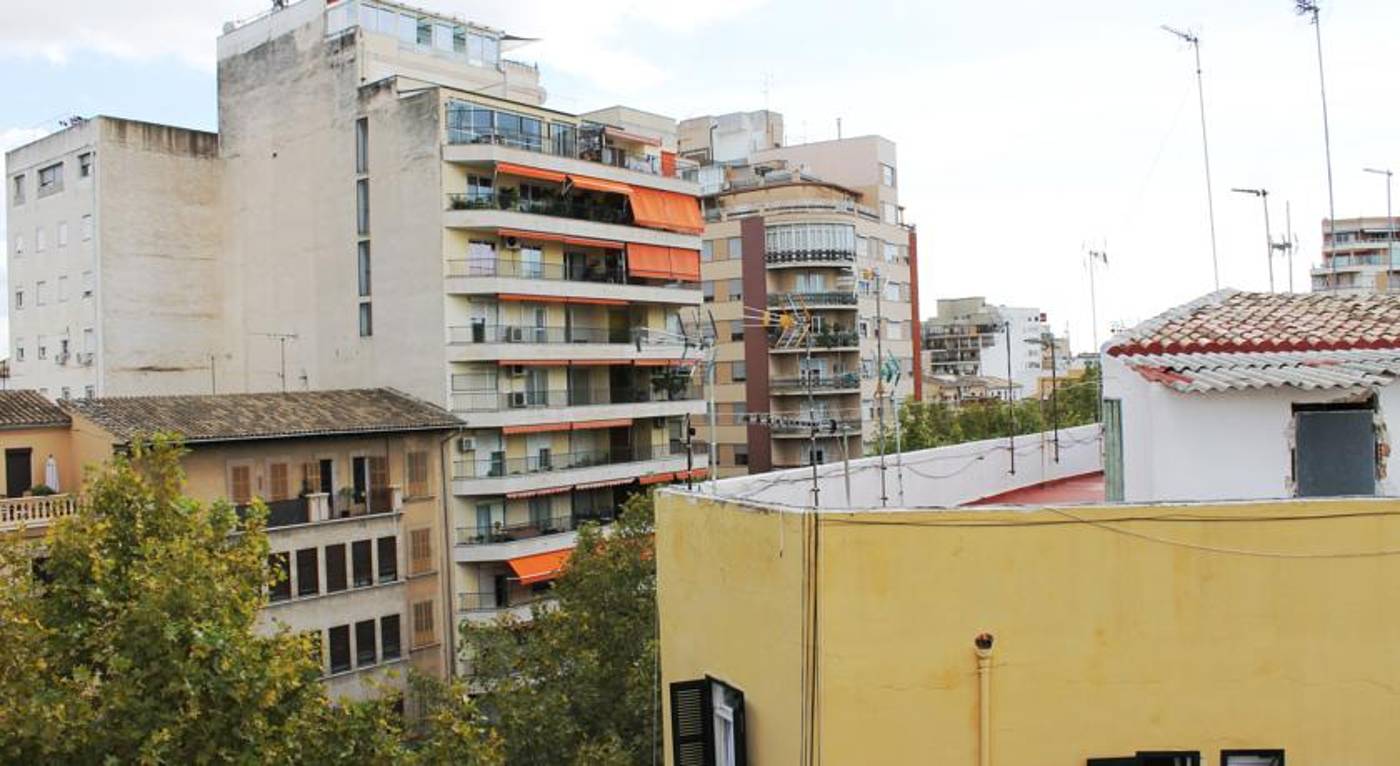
[1312,216,1400,295]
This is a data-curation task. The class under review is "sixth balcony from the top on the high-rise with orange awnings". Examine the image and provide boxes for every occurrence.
[452,445,708,496]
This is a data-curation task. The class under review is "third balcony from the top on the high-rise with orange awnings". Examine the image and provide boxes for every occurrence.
[447,256,701,305]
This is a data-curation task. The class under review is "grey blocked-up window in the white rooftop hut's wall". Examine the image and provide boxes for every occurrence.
[1294,403,1376,497]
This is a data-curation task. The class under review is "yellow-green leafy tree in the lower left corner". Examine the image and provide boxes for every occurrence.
[0,437,500,765]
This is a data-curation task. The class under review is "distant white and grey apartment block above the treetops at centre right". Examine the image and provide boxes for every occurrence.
[921,297,1052,399]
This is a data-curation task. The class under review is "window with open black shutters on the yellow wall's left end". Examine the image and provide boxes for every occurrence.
[671,678,748,766]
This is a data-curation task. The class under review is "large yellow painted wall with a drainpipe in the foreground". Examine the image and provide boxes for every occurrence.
[658,493,1400,766]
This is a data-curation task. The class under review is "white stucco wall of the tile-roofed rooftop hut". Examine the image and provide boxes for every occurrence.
[1103,354,1400,503]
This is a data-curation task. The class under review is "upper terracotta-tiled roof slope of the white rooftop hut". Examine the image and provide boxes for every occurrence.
[1107,290,1400,356]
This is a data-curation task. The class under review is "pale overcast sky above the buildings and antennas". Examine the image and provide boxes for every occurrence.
[0,0,1400,350]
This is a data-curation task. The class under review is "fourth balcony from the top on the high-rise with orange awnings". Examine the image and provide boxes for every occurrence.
[448,323,694,361]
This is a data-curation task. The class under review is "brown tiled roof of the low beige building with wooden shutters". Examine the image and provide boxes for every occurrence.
[64,388,462,443]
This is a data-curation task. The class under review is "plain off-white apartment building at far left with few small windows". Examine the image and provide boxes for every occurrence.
[6,116,224,399]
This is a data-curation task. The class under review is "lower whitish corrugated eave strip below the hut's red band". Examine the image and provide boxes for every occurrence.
[1123,349,1400,394]
